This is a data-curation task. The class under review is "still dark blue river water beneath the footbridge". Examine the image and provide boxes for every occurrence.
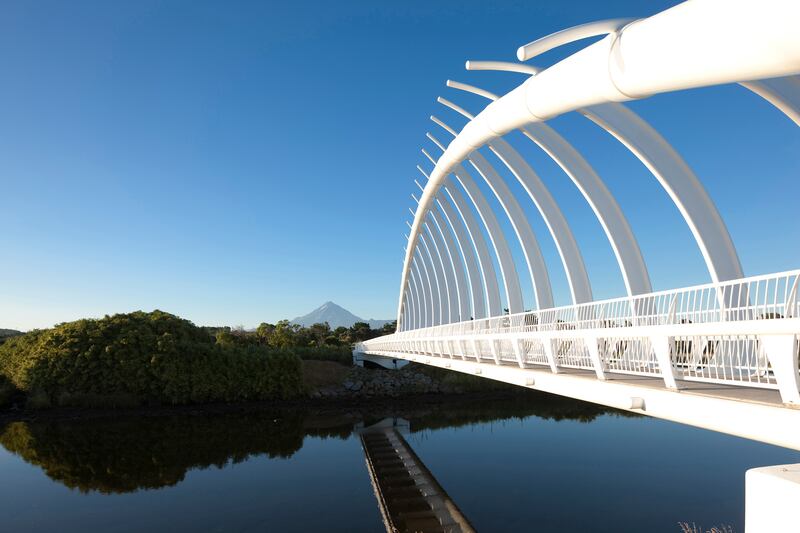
[0,394,800,533]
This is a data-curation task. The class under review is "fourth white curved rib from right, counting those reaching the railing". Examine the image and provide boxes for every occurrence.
[469,150,554,313]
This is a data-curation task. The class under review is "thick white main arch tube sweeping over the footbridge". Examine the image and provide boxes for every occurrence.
[397,0,800,320]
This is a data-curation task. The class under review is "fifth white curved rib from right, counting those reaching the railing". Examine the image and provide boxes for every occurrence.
[454,165,525,316]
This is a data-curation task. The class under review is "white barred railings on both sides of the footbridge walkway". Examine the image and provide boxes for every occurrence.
[364,270,800,402]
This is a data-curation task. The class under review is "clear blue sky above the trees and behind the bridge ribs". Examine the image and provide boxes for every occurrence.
[0,0,800,329]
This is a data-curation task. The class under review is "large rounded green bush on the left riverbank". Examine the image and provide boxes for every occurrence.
[0,311,303,407]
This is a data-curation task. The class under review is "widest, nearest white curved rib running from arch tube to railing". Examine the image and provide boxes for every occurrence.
[579,104,744,283]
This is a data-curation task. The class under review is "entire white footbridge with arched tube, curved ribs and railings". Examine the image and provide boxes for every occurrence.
[356,0,800,490]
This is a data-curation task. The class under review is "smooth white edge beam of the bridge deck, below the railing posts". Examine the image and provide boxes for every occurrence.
[364,350,800,450]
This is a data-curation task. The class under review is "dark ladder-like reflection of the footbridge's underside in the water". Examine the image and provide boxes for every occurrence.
[358,418,474,533]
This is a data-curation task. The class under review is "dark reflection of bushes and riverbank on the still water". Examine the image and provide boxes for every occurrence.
[0,392,620,494]
